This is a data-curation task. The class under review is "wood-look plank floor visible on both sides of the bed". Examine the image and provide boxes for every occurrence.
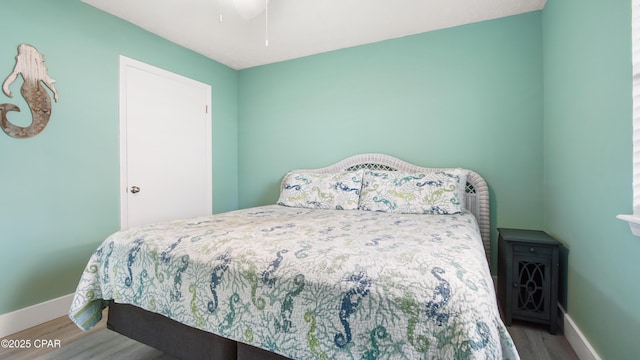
[0,314,578,360]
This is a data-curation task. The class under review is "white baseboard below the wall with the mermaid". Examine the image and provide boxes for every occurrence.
[0,294,74,338]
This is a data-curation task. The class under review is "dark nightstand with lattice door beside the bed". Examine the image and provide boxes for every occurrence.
[498,228,560,335]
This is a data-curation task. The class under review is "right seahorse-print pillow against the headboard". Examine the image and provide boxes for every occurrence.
[359,169,467,215]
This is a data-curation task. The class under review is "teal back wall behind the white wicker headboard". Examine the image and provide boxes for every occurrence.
[238,12,543,272]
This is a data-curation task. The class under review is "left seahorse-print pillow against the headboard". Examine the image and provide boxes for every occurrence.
[278,170,364,210]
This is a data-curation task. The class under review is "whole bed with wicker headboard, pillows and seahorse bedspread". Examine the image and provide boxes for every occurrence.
[69,154,519,359]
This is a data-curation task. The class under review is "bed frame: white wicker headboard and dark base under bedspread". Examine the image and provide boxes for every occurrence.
[107,154,491,360]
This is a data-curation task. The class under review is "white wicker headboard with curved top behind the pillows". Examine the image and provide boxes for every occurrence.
[294,154,491,265]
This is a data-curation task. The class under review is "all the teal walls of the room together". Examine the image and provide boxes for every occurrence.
[0,0,640,359]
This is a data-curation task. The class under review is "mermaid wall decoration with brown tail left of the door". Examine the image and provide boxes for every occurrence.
[0,44,58,139]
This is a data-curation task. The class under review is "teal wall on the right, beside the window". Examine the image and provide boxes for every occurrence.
[543,0,640,360]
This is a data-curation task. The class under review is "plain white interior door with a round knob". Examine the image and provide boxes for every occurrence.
[120,56,212,229]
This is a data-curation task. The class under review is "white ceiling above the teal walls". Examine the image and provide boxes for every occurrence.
[82,0,547,69]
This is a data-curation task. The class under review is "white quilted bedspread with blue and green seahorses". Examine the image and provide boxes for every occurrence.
[69,205,518,359]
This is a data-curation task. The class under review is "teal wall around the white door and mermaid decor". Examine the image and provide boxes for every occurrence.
[0,0,238,314]
